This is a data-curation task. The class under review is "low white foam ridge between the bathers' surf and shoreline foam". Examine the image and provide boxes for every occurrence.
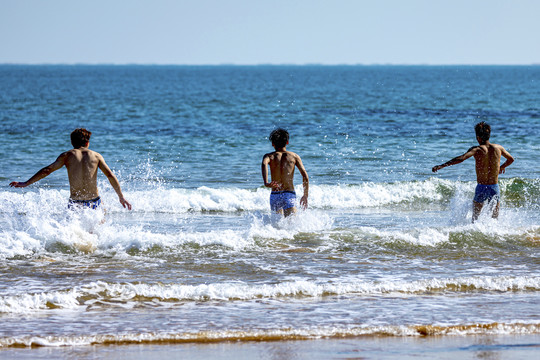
[0,276,540,313]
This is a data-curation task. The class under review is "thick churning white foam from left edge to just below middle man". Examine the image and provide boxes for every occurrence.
[0,192,332,258]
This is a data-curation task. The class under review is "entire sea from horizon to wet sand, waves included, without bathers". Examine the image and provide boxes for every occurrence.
[0,65,540,357]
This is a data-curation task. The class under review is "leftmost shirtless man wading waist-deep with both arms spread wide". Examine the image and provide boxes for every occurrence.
[9,129,131,210]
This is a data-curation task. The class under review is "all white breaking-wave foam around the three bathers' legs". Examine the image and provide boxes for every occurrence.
[0,179,538,258]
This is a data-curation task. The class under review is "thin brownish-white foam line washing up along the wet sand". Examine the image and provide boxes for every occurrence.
[0,321,540,348]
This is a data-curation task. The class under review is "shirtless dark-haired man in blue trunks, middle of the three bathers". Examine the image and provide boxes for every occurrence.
[261,129,309,216]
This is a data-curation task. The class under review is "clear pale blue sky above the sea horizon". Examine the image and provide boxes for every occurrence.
[0,0,540,64]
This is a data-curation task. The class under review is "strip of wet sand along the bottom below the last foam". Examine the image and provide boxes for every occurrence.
[4,335,540,360]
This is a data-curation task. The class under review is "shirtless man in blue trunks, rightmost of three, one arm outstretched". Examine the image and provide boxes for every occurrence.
[432,121,514,222]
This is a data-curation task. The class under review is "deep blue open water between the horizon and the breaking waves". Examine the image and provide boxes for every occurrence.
[0,66,540,187]
